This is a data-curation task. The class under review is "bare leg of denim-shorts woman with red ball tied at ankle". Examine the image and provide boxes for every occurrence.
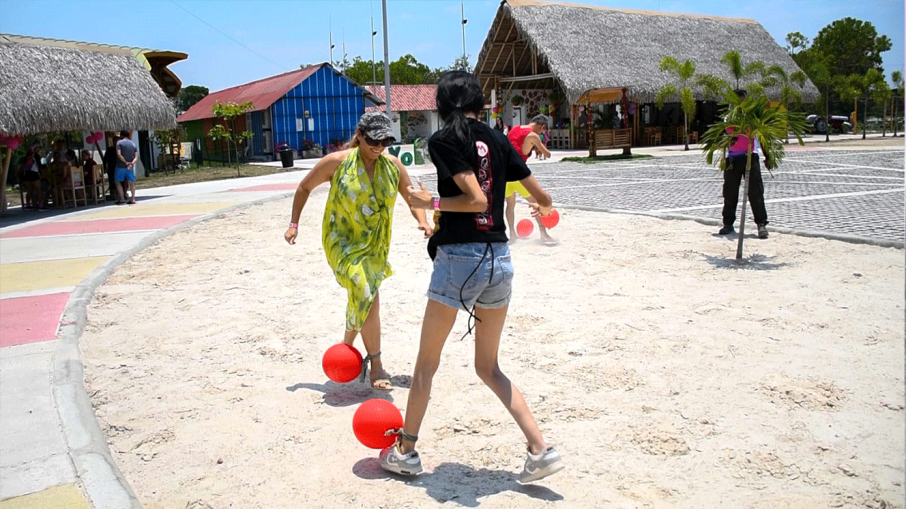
[400,300,457,454]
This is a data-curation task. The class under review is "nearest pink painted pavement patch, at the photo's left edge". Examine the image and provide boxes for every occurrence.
[0,292,69,348]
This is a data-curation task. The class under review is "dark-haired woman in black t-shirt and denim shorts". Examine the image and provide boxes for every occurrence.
[380,71,563,482]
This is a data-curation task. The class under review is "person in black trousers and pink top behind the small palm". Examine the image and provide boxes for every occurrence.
[717,90,771,239]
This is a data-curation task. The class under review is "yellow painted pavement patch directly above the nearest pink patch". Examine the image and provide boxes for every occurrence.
[0,256,110,293]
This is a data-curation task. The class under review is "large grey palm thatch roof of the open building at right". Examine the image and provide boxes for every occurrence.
[475,0,819,102]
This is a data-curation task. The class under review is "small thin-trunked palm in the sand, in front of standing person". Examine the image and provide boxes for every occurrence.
[702,87,806,260]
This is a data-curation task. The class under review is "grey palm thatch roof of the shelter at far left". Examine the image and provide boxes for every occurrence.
[0,37,176,135]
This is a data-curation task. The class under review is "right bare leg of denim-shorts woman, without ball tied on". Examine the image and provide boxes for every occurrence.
[474,307,547,454]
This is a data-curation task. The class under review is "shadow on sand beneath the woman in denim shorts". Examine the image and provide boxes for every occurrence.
[352,454,563,507]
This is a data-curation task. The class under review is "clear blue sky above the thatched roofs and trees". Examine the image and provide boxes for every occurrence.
[0,0,906,92]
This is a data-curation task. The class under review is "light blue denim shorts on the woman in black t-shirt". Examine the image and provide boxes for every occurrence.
[428,242,513,310]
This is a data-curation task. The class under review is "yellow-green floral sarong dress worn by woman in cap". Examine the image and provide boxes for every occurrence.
[321,149,400,330]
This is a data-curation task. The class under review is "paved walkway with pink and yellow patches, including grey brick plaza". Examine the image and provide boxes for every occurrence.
[0,133,904,509]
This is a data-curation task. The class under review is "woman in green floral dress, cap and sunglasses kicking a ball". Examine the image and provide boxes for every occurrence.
[284,112,432,390]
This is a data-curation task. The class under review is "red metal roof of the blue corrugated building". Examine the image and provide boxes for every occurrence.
[176,63,327,122]
